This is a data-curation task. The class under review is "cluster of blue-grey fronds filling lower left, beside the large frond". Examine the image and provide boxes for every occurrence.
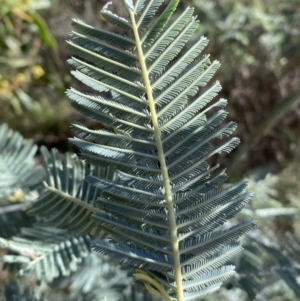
[0,124,154,301]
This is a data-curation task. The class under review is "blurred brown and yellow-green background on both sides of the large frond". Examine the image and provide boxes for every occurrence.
[0,0,300,301]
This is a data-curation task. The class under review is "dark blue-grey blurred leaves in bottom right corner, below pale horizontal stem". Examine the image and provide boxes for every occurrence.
[235,233,300,301]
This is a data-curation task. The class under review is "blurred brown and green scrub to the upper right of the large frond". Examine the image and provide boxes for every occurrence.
[185,0,300,177]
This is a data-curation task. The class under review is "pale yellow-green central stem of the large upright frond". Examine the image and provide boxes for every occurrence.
[129,11,184,301]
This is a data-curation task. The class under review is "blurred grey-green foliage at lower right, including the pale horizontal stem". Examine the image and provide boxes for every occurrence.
[229,170,300,301]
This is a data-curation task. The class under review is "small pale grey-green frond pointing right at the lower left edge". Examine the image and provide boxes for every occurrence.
[0,225,91,283]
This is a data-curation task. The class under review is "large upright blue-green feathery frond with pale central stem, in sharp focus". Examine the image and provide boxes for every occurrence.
[53,0,254,301]
